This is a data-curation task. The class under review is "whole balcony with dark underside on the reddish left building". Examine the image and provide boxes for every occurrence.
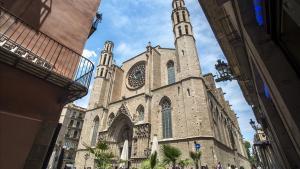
[0,7,94,103]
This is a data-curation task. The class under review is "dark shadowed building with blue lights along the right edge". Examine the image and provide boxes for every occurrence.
[199,0,300,169]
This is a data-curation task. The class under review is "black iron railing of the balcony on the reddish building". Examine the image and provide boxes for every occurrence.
[0,7,94,88]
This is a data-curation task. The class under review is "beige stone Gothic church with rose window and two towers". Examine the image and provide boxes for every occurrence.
[75,0,250,169]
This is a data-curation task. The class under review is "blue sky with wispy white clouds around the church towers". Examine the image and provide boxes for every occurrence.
[75,0,254,142]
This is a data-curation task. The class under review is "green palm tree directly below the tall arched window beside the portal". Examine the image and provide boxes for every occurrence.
[162,145,181,169]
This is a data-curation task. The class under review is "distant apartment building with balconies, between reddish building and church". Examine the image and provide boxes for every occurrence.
[48,104,86,169]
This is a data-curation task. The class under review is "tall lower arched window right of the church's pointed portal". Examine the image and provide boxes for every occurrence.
[160,98,172,138]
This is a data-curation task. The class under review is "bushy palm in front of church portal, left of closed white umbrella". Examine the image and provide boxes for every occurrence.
[84,141,114,169]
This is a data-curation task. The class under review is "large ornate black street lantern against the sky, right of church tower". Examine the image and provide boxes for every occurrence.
[215,59,236,82]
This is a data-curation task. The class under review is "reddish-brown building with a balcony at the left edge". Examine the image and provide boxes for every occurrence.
[0,0,100,169]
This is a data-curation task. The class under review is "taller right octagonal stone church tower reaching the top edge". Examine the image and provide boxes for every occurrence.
[172,0,201,80]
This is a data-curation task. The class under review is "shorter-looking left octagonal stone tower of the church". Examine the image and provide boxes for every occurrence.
[89,41,114,109]
